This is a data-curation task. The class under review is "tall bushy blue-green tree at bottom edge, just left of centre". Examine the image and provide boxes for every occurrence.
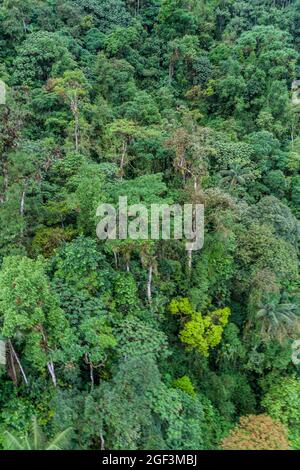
[83,356,160,450]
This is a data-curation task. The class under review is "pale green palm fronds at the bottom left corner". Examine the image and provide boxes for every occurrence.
[4,417,72,450]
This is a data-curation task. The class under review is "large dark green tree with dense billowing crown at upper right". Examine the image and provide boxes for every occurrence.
[214,25,296,135]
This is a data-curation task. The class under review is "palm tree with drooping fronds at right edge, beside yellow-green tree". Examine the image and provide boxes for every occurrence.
[257,301,300,341]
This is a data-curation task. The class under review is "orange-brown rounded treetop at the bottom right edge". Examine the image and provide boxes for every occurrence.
[221,415,289,450]
